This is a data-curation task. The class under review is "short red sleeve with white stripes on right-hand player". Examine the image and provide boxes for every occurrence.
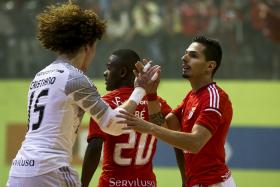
[195,93,223,134]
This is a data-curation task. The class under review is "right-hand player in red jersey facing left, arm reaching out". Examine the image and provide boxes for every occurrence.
[119,36,235,187]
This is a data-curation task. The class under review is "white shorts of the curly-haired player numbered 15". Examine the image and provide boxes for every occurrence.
[7,166,81,187]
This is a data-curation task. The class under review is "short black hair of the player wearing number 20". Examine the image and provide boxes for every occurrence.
[112,49,140,72]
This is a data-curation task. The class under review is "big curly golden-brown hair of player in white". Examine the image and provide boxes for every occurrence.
[37,3,106,54]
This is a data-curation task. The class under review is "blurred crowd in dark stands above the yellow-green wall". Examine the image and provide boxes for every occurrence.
[0,0,280,79]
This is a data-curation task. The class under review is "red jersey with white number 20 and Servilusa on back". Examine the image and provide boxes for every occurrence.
[88,87,171,187]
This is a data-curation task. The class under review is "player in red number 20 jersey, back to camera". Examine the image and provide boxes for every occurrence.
[81,49,171,187]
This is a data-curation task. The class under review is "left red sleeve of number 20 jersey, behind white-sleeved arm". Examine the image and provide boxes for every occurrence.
[87,94,116,141]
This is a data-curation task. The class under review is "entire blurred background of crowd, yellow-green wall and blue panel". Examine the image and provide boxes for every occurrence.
[0,0,280,187]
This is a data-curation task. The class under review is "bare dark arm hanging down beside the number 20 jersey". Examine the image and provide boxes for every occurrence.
[81,138,103,187]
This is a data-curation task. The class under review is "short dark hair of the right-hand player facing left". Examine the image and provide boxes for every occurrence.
[192,36,223,75]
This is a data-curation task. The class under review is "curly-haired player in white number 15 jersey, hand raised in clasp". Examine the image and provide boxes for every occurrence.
[7,3,160,187]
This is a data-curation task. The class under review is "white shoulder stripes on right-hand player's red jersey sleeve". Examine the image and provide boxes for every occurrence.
[205,84,222,116]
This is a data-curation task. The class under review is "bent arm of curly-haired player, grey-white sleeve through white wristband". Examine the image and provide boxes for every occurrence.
[68,75,146,135]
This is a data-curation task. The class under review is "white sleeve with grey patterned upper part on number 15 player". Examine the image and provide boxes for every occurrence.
[65,75,128,136]
